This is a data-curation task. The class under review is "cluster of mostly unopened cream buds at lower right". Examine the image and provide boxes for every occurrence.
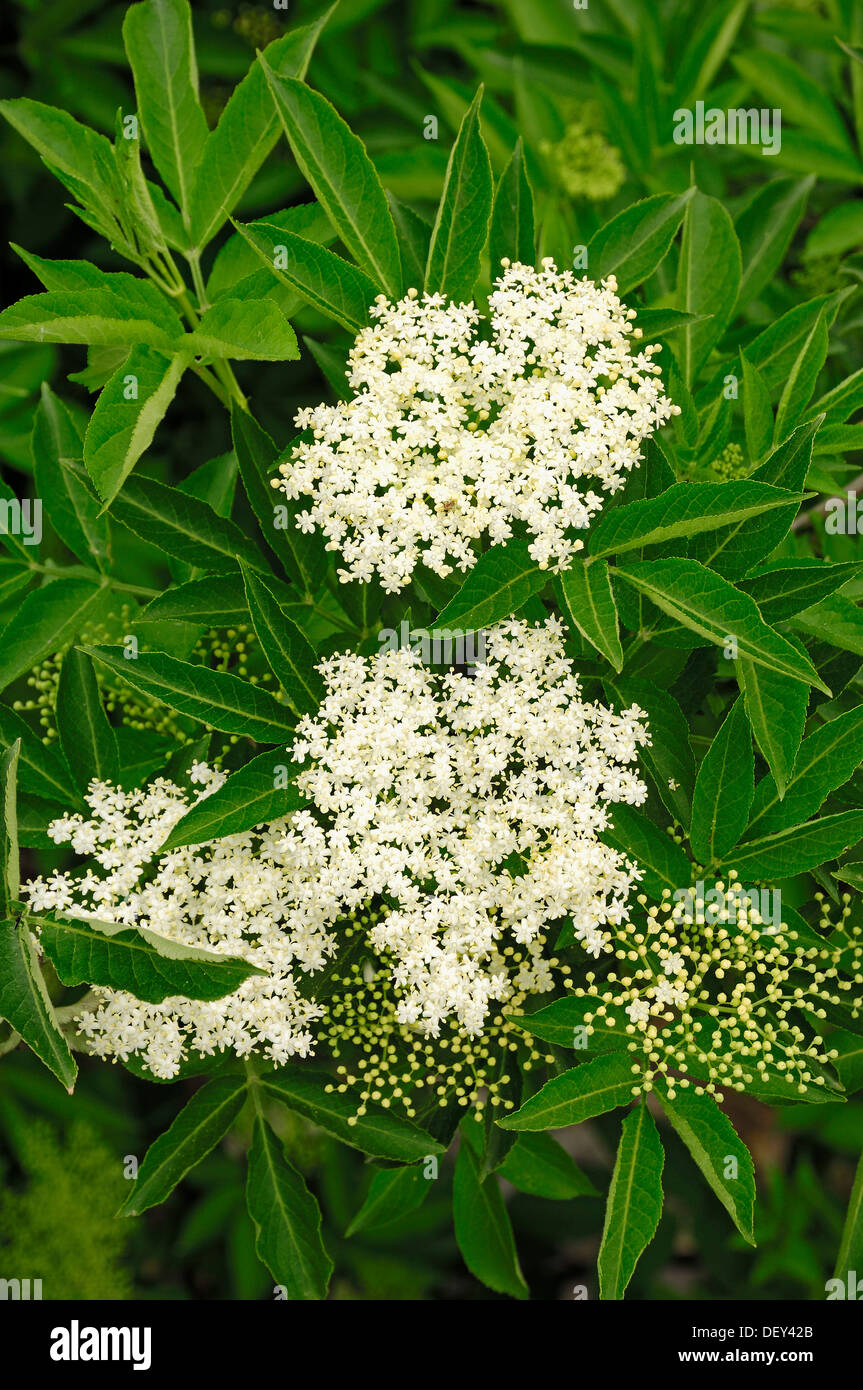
[564,872,863,1099]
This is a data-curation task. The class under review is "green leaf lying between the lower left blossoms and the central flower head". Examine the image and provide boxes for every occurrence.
[161,748,306,853]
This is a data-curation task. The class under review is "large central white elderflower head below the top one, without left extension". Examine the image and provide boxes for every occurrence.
[289,619,648,1034]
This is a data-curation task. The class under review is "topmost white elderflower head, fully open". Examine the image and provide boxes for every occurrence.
[272,259,678,592]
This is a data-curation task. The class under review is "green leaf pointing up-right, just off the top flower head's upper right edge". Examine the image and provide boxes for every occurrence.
[588,188,695,296]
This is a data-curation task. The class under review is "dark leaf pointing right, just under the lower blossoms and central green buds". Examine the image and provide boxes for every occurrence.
[260,1065,443,1163]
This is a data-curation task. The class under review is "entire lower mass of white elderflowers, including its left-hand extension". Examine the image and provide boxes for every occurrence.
[20,620,648,1076]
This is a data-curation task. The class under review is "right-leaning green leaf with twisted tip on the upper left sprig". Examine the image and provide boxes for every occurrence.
[190,7,335,249]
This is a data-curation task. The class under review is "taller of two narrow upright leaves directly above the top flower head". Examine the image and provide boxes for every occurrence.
[425,86,493,303]
